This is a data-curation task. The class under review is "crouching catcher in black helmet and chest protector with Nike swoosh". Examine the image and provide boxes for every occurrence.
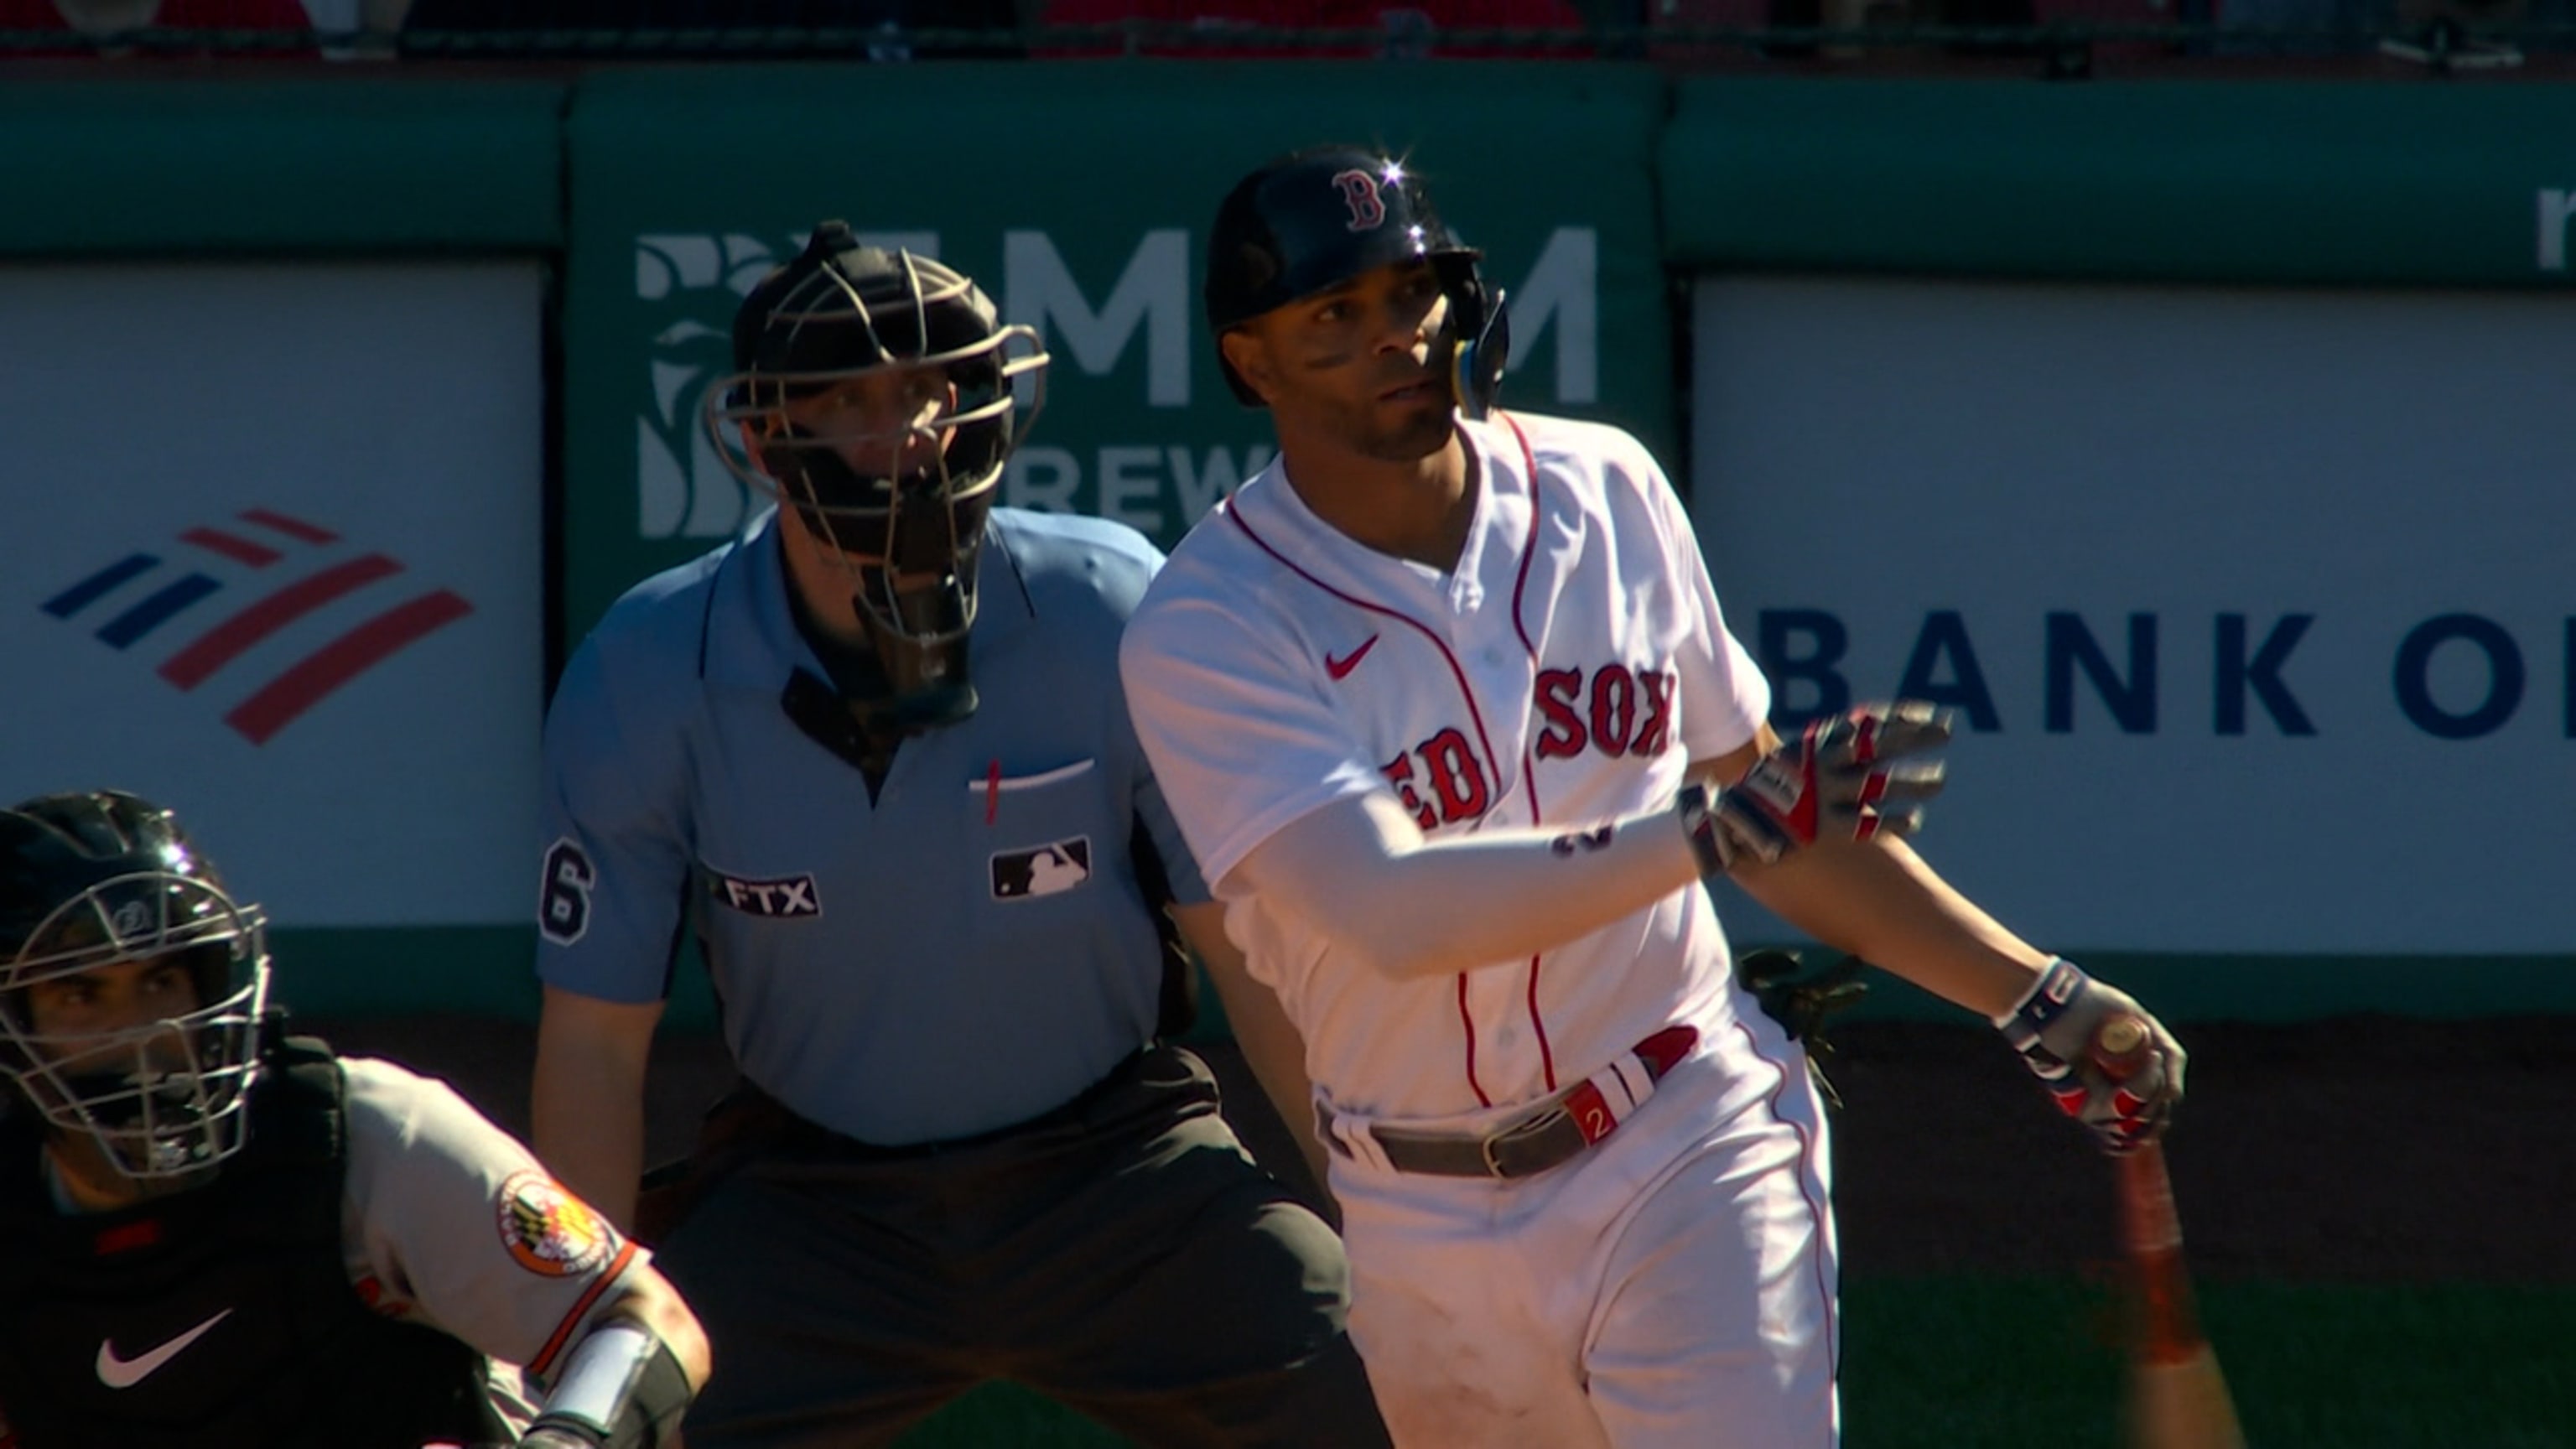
[0,792,709,1449]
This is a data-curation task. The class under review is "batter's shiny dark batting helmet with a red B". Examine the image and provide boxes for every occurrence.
[1206,144,1512,418]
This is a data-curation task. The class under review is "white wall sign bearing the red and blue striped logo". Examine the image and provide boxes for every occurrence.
[0,263,543,928]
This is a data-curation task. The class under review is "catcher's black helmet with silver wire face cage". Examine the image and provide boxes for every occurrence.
[0,792,267,1178]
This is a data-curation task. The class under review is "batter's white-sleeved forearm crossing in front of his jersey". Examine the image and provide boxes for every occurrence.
[1237,797,1701,977]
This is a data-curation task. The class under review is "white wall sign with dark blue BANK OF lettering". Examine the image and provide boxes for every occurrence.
[1690,278,2576,954]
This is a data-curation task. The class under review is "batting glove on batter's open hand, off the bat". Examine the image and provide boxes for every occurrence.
[1677,699,1950,876]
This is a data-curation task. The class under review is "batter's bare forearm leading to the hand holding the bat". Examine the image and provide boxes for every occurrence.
[1733,838,2048,1015]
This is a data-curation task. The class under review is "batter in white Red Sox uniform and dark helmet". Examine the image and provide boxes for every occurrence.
[1120,147,2184,1449]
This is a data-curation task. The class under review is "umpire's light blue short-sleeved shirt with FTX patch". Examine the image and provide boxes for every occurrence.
[538,508,1208,1145]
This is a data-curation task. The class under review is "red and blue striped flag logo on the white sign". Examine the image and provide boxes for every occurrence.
[41,508,474,745]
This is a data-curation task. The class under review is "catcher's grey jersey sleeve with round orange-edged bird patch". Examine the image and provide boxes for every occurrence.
[340,1057,649,1374]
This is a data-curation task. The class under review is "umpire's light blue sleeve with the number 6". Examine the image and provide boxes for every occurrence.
[536,634,690,1003]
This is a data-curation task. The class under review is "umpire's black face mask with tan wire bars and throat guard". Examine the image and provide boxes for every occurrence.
[706,221,1048,724]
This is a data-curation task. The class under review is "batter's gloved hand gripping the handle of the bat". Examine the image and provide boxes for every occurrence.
[1997,959,2189,1152]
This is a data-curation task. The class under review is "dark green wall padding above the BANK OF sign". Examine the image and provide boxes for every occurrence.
[1656,77,2576,286]
